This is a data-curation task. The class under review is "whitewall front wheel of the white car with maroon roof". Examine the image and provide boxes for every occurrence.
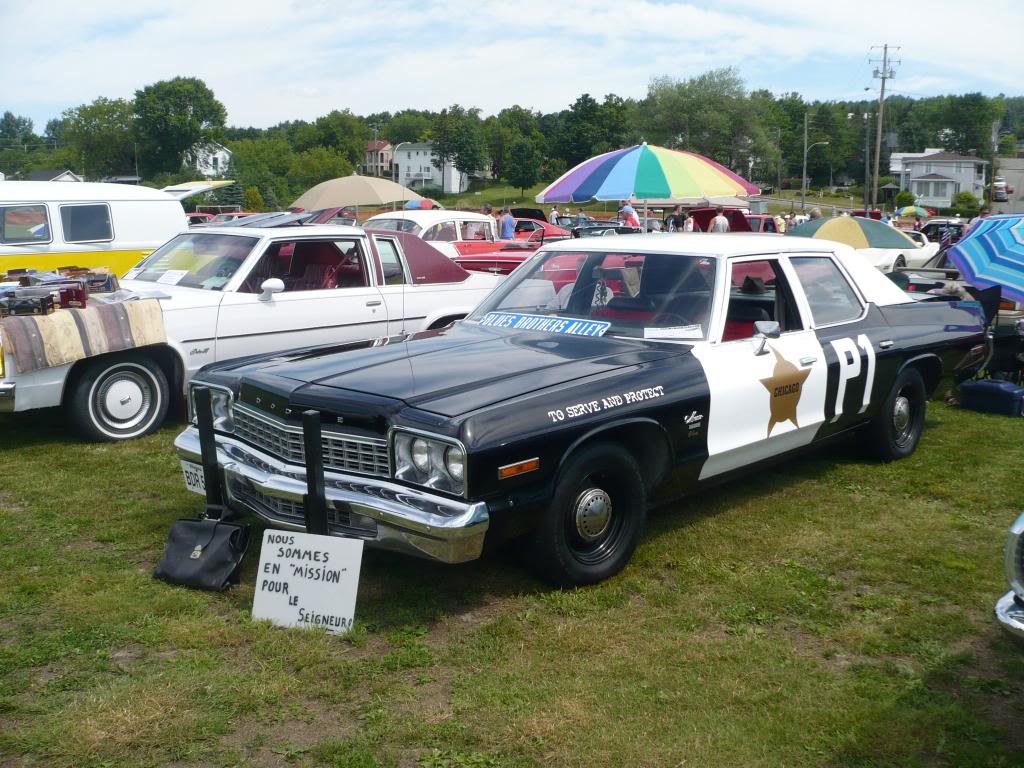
[65,353,170,442]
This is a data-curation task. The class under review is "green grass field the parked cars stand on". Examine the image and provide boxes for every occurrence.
[0,403,1024,768]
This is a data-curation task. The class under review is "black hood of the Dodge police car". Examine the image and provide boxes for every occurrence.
[239,323,691,417]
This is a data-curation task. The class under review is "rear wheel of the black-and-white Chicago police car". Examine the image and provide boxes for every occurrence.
[859,368,928,462]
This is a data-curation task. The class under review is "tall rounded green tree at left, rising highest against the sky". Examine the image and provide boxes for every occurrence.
[134,77,227,174]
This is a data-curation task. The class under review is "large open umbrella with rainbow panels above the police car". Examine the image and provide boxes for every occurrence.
[537,143,761,203]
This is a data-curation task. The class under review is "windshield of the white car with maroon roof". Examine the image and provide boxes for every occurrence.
[125,232,259,291]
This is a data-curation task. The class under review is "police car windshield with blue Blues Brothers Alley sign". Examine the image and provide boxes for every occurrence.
[469,250,717,341]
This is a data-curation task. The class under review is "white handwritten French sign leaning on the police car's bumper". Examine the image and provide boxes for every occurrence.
[253,530,362,635]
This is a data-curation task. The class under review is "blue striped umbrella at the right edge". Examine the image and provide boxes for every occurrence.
[949,213,1024,302]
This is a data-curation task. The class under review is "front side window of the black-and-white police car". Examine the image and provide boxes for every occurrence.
[722,259,803,341]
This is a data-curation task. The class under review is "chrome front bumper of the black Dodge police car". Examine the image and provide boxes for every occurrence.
[174,427,489,563]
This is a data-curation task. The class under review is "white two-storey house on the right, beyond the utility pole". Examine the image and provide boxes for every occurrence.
[892,150,988,208]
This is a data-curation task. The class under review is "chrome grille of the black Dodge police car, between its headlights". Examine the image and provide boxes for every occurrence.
[232,402,390,477]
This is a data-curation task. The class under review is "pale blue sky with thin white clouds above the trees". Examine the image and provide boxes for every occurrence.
[0,0,1024,130]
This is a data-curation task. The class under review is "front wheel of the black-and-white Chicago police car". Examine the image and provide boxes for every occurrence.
[530,442,647,587]
